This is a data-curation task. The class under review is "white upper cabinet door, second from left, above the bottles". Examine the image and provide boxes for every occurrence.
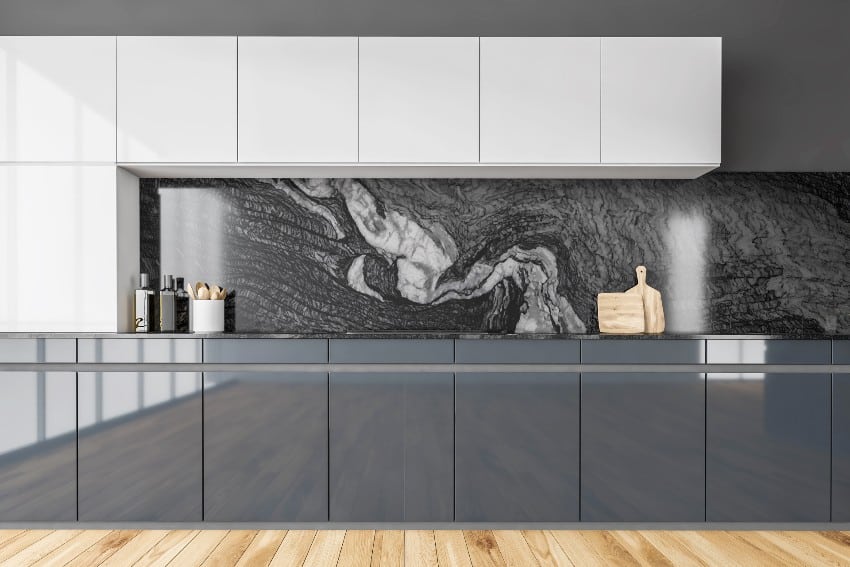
[118,37,236,162]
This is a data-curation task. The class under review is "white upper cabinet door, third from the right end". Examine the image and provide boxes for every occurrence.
[360,37,478,163]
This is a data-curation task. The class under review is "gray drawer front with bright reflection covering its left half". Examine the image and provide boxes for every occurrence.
[707,339,832,364]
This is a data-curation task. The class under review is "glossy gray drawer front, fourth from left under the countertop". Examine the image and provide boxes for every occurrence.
[329,339,454,364]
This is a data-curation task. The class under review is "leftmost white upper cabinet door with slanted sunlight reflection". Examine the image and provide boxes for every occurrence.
[0,37,115,163]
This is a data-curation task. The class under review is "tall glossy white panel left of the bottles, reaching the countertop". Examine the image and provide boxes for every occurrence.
[0,165,117,332]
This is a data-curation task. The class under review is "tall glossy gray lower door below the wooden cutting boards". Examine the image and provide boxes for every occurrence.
[581,372,705,522]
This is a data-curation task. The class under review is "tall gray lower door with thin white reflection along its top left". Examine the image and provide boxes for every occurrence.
[706,372,831,522]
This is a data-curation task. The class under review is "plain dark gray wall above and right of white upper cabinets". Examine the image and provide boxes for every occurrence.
[0,0,850,171]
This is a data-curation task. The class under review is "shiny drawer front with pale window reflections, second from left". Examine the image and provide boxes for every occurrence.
[79,338,201,364]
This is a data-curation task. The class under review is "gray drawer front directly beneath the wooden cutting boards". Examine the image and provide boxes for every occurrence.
[581,339,705,364]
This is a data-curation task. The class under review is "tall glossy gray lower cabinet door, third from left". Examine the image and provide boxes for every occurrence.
[204,372,328,522]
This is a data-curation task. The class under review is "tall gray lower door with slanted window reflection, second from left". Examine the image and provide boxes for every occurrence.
[78,372,203,522]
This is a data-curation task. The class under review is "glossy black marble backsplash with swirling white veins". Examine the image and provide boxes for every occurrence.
[141,173,850,334]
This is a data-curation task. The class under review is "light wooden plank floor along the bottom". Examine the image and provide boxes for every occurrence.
[0,530,850,567]
